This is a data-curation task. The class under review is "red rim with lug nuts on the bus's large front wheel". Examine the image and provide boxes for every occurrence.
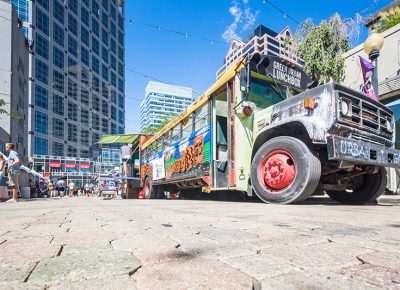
[259,150,296,191]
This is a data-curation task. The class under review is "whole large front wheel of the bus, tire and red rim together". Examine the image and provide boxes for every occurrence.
[251,136,321,204]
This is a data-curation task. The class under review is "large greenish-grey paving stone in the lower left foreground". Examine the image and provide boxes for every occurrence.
[28,250,141,286]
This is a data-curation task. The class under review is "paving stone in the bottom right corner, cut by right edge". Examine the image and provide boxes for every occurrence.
[341,264,400,289]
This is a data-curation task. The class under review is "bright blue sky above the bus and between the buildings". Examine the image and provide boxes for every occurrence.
[125,0,391,133]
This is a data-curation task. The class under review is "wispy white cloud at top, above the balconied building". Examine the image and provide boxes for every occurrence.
[222,0,259,43]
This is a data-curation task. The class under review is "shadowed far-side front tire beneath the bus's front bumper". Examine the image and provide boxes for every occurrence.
[326,167,387,204]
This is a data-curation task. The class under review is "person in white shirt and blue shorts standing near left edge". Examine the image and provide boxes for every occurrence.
[6,143,22,202]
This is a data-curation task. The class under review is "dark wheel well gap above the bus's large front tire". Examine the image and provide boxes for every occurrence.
[251,122,313,160]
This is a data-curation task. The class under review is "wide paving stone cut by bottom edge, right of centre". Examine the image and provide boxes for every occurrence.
[261,271,380,290]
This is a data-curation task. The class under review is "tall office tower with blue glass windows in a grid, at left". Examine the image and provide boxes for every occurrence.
[8,0,125,158]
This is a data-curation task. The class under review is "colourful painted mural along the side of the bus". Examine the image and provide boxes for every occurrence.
[141,125,211,181]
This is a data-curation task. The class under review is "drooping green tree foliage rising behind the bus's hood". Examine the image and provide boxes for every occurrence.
[288,14,354,84]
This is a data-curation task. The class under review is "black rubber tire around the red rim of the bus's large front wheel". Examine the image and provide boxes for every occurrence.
[251,136,321,204]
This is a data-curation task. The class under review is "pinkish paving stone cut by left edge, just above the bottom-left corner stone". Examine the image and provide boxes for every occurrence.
[0,237,60,265]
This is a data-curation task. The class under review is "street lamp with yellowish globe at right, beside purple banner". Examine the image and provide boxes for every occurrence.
[364,31,384,98]
